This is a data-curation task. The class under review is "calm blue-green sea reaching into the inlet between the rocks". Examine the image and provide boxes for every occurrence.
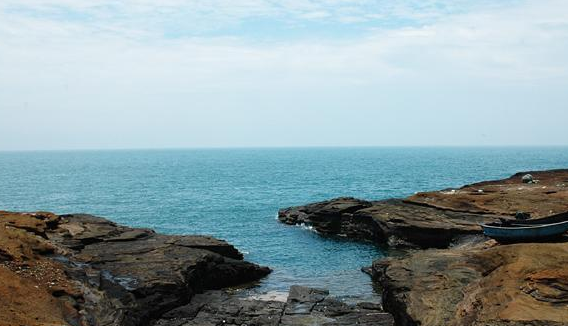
[0,147,568,297]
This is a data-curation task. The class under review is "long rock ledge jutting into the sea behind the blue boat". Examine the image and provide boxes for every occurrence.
[278,170,568,248]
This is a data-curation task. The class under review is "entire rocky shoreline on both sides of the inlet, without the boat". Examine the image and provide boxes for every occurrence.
[0,170,568,326]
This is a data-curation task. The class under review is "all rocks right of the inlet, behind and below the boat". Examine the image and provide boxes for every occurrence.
[278,170,568,326]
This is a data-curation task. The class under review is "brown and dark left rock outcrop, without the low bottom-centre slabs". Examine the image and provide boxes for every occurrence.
[0,211,270,326]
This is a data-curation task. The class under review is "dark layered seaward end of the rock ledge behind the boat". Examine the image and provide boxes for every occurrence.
[278,198,501,248]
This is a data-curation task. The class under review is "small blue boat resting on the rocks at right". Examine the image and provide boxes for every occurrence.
[481,212,568,242]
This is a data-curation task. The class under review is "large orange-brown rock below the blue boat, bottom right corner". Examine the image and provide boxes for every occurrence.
[373,239,568,326]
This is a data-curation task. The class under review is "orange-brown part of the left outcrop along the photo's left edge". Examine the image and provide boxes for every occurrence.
[0,211,82,326]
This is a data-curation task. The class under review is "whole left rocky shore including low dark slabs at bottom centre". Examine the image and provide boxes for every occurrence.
[0,211,394,326]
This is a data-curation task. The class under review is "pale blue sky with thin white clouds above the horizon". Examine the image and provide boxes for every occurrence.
[0,0,568,150]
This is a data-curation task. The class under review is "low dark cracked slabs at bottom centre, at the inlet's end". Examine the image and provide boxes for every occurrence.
[154,286,394,326]
